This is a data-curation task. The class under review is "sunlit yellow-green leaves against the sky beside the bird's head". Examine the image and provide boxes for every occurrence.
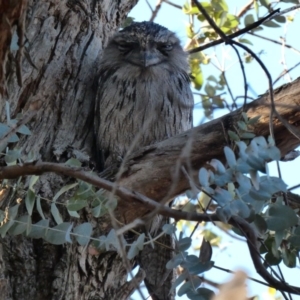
[182,0,298,118]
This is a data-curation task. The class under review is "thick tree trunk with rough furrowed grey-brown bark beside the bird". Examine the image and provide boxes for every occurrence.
[0,0,139,300]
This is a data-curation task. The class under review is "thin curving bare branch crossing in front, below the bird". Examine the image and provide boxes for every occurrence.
[0,162,300,294]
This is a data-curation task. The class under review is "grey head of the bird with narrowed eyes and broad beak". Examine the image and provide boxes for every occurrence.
[102,22,188,71]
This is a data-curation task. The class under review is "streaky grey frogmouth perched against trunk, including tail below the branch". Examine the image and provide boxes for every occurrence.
[94,21,194,300]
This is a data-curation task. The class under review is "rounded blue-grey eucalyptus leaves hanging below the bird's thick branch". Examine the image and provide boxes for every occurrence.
[0,122,294,299]
